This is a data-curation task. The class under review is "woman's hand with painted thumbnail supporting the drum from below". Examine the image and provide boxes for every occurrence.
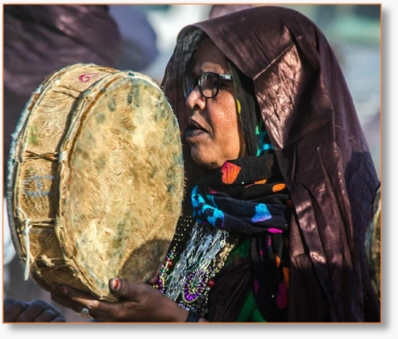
[52,278,188,322]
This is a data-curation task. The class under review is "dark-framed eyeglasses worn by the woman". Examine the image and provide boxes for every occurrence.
[183,72,232,99]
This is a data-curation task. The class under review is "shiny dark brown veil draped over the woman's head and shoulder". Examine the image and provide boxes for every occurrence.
[163,7,380,321]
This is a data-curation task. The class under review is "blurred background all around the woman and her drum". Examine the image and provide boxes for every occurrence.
[3,4,381,322]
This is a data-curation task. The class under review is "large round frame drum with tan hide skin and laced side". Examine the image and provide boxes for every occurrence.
[7,64,184,301]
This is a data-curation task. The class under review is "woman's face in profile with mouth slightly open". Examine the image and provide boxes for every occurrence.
[185,39,243,169]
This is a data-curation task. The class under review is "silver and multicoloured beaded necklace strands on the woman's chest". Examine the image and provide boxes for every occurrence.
[154,219,237,317]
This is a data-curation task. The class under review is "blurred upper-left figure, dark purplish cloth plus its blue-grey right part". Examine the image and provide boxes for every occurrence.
[4,5,158,187]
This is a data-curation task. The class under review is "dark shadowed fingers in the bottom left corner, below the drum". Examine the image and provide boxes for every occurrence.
[4,299,65,323]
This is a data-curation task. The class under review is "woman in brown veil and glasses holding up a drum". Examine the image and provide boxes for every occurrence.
[5,7,380,322]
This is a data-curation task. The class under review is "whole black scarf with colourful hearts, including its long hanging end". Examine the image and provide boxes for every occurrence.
[191,150,290,321]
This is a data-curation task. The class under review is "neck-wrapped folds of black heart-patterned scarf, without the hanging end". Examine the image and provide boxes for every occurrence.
[191,154,288,235]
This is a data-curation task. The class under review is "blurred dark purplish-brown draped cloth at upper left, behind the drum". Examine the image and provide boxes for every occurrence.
[4,5,120,186]
